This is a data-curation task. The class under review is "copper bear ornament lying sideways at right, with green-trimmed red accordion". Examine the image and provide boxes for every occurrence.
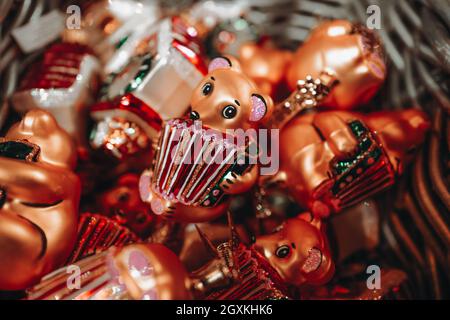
[263,109,429,216]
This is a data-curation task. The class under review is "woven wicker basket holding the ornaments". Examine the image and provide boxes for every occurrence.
[0,0,450,298]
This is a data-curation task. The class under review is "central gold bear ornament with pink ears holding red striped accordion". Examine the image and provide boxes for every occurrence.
[139,57,273,222]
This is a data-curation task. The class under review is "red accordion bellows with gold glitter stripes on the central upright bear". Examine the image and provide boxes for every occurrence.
[147,120,255,207]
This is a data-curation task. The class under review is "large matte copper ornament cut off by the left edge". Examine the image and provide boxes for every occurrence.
[0,110,81,290]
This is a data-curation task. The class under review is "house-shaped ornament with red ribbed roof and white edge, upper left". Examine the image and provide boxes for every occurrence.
[12,43,100,146]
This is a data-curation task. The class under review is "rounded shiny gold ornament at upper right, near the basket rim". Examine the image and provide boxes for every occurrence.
[287,20,386,110]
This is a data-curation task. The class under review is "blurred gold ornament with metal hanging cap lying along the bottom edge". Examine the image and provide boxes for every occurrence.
[27,243,236,300]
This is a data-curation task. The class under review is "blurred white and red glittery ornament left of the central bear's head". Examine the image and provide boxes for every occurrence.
[90,17,206,159]
